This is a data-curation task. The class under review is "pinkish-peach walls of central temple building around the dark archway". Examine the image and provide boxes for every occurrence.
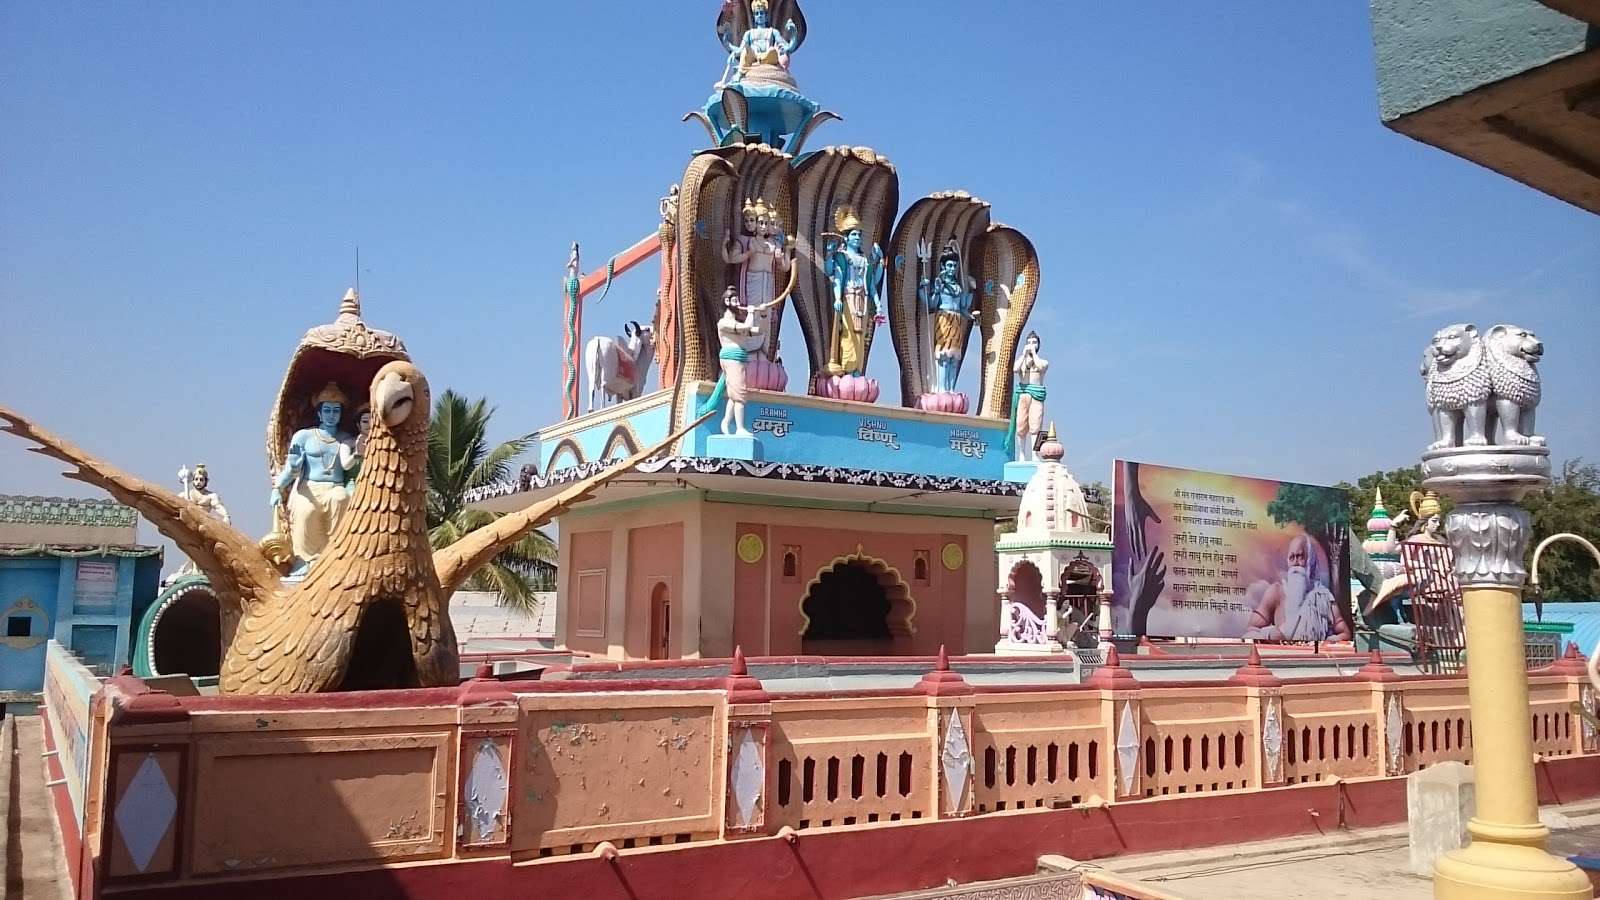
[557,492,998,658]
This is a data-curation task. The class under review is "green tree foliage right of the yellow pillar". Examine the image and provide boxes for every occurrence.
[1522,460,1600,601]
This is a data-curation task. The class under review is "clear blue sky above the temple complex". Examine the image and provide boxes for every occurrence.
[0,0,1600,560]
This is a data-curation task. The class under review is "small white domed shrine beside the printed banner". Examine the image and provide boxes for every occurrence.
[995,426,1112,655]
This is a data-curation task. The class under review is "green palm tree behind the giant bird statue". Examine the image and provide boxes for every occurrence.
[427,391,555,612]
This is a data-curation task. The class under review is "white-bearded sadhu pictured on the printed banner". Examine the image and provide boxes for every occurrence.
[1243,533,1350,641]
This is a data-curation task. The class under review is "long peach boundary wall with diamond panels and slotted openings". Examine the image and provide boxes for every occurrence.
[80,663,1597,897]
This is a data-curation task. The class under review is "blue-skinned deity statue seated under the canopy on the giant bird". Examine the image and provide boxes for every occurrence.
[272,381,355,575]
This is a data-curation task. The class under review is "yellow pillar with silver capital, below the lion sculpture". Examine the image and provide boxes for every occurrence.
[1422,445,1594,900]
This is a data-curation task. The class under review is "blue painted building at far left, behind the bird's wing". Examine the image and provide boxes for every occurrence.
[0,496,162,706]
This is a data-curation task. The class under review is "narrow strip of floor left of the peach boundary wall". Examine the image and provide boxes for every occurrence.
[0,716,70,900]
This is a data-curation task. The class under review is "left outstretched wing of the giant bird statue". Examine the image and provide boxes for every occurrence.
[0,407,280,610]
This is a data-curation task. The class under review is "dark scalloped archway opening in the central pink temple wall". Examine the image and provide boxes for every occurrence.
[800,548,917,657]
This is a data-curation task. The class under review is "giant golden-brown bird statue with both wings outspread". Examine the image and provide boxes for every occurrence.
[0,362,698,693]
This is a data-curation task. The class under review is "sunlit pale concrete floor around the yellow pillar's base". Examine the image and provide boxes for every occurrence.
[1094,801,1600,900]
